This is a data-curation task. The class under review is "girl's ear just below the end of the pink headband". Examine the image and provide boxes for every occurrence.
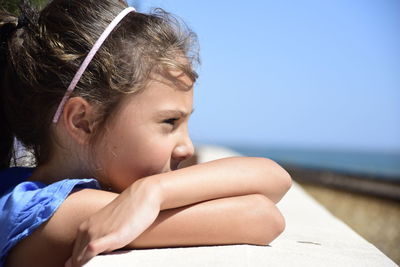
[62,97,93,144]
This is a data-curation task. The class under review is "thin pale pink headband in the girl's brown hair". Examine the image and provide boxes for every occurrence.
[53,7,136,123]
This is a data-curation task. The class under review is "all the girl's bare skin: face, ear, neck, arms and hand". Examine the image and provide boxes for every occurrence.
[6,69,291,266]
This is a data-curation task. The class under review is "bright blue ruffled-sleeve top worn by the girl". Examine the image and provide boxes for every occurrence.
[0,167,100,267]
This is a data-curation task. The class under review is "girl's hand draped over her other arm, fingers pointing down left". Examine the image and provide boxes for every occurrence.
[65,179,160,267]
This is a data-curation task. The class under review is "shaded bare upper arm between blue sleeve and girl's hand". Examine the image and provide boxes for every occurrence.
[7,188,118,266]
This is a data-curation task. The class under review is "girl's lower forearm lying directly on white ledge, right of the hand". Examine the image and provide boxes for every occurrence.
[127,194,284,248]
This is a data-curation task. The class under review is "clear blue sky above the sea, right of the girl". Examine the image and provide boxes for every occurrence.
[128,0,400,152]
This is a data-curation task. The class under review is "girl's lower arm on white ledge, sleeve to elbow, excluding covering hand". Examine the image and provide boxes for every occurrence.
[5,194,284,267]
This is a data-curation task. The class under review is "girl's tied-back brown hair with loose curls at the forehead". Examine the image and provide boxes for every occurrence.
[0,0,198,169]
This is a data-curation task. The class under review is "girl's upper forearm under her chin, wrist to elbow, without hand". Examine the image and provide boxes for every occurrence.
[139,157,291,210]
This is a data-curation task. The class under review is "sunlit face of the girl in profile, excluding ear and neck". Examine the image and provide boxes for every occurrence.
[96,75,194,192]
